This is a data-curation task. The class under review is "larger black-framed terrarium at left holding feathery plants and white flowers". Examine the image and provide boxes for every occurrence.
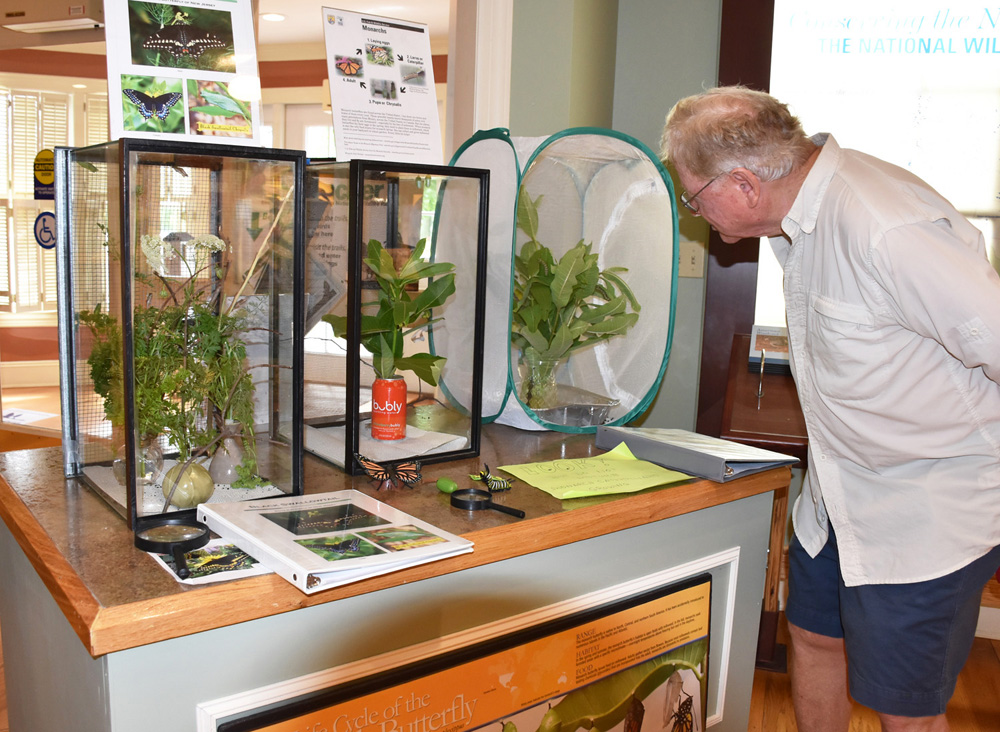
[56,139,305,530]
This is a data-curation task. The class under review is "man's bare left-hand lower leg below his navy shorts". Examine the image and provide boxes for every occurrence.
[788,623,852,732]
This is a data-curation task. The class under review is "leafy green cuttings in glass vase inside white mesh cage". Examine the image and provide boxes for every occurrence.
[511,187,640,409]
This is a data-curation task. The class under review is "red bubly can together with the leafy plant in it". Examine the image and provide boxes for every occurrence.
[323,239,455,439]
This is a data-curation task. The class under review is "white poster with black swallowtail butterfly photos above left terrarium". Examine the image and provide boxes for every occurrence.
[104,0,260,145]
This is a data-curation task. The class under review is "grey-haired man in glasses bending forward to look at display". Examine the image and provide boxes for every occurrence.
[662,87,1000,732]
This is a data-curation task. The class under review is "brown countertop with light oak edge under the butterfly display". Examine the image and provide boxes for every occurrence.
[0,425,790,657]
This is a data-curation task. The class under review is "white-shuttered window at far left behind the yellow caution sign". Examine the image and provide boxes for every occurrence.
[0,88,71,313]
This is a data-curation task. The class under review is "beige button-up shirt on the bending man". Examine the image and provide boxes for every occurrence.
[770,135,1000,585]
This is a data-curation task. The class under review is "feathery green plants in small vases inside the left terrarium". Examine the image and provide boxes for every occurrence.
[78,235,270,508]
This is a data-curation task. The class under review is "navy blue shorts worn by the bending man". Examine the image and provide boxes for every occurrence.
[785,531,1000,717]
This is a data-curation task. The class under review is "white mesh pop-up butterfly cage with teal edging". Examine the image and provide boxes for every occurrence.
[441,128,678,433]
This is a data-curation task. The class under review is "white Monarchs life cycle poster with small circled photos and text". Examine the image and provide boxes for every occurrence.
[323,8,443,165]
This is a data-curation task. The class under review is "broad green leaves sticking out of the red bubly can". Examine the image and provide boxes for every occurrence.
[323,239,455,386]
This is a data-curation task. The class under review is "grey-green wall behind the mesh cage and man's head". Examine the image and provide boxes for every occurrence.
[510,0,729,430]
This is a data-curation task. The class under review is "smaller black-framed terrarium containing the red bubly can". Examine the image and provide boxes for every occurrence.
[304,160,489,473]
